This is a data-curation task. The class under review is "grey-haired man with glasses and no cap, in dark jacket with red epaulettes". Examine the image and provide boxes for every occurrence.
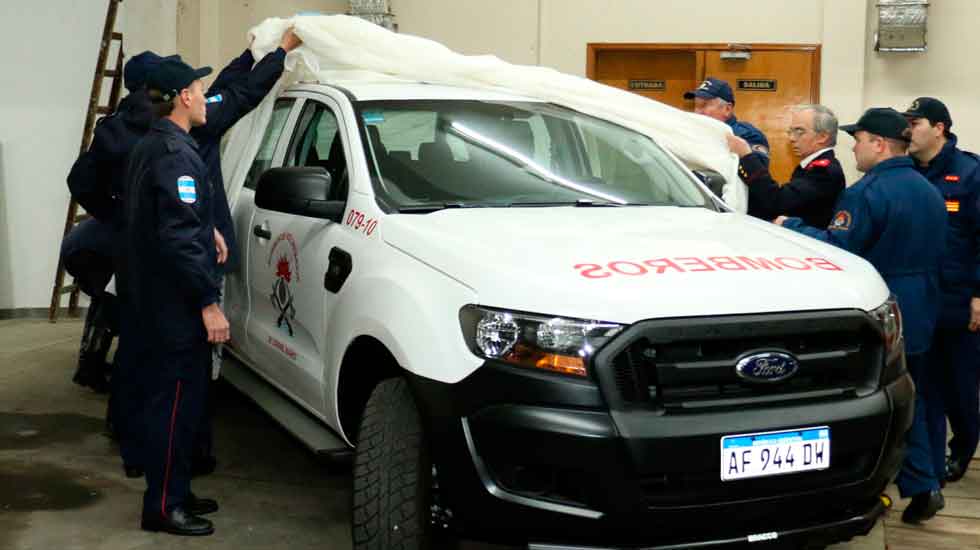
[728,105,845,227]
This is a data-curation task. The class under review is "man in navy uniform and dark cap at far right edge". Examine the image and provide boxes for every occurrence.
[903,97,980,482]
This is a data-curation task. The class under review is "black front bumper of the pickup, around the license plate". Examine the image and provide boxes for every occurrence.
[413,350,914,550]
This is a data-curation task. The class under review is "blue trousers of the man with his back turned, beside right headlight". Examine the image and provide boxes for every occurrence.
[895,353,945,498]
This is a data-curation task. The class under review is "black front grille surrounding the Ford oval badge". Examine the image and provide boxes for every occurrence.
[597,311,881,413]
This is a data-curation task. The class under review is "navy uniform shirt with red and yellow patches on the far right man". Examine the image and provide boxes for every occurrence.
[916,134,980,328]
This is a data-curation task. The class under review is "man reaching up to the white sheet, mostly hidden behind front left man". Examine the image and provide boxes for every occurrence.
[191,29,302,475]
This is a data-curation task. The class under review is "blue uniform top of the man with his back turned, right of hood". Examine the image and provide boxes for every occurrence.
[783,157,946,354]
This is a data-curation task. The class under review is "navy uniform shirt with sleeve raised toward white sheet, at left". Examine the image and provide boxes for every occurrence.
[191,48,286,271]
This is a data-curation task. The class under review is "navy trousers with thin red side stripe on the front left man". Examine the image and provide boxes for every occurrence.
[143,342,211,516]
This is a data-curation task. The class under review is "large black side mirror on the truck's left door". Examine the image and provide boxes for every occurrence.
[255,166,345,223]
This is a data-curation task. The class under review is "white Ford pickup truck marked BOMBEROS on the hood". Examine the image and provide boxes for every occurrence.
[225,78,914,550]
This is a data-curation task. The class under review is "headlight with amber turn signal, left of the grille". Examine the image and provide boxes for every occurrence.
[459,306,623,376]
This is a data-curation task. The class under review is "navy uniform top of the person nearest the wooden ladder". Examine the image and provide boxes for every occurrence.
[68,90,154,223]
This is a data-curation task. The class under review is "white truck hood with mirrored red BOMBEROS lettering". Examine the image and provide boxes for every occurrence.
[379,207,888,323]
